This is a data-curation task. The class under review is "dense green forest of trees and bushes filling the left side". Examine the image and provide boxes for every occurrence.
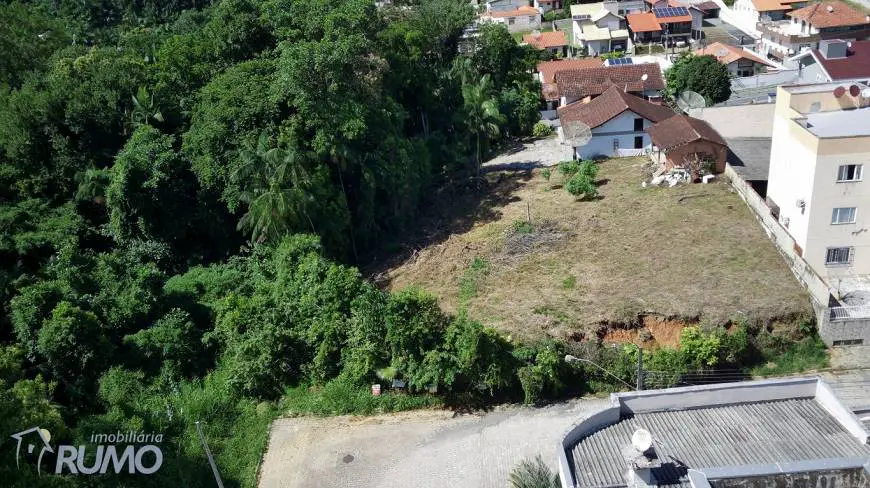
[0,0,552,487]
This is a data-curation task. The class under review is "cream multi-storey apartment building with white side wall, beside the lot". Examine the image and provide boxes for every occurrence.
[767,83,870,276]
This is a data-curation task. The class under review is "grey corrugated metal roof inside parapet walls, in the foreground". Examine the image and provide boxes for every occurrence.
[569,399,870,488]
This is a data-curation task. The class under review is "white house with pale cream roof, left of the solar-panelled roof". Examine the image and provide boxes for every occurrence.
[571,1,629,56]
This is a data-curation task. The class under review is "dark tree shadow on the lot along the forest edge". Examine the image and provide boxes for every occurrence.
[362,169,533,287]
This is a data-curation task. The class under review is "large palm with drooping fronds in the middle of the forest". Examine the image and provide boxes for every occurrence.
[231,134,314,243]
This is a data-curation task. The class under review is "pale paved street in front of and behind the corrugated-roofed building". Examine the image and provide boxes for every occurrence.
[260,369,870,488]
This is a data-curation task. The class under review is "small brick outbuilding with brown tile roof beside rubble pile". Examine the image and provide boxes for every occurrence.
[646,115,728,176]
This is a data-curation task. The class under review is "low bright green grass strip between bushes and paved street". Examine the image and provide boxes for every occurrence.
[284,380,443,416]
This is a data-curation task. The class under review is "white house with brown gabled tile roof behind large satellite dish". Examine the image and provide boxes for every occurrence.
[558,85,675,159]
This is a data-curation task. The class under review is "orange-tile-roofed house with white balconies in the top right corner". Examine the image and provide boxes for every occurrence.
[757,0,870,60]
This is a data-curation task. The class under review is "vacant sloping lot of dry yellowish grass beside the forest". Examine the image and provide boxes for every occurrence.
[380,158,811,337]
